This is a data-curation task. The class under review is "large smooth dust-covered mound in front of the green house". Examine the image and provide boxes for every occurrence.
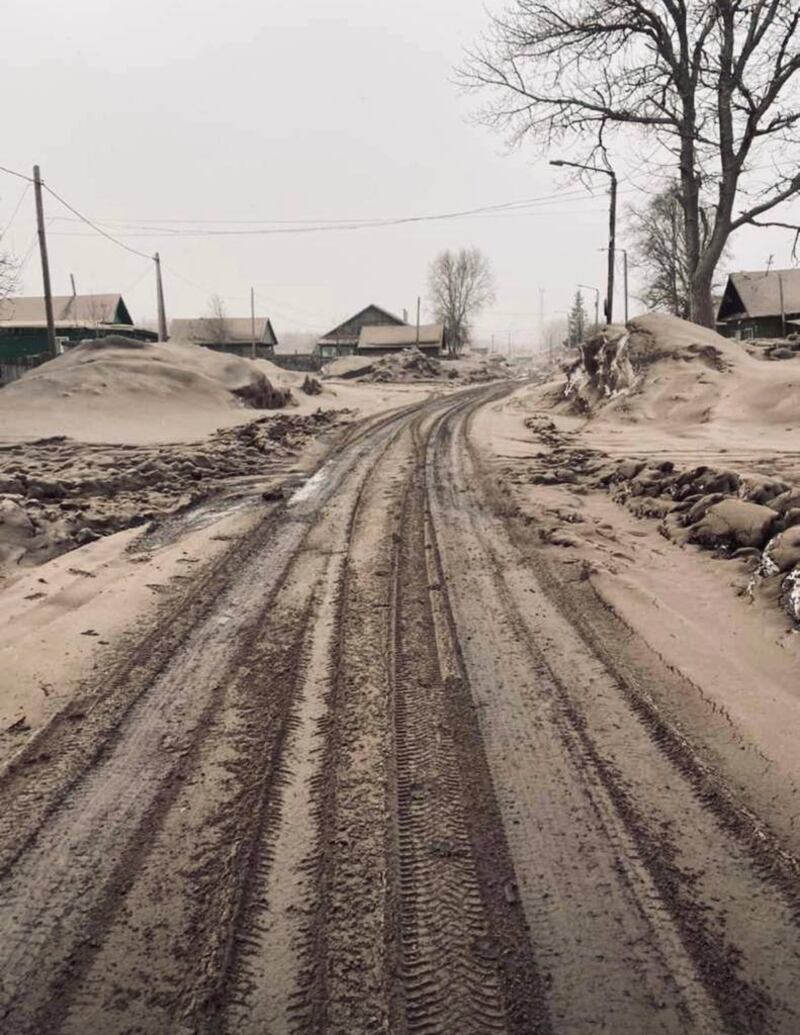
[0,335,292,442]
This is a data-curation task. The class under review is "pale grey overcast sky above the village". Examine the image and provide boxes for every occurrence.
[0,0,792,345]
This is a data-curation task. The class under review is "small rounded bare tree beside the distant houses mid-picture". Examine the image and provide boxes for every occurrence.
[428,248,495,356]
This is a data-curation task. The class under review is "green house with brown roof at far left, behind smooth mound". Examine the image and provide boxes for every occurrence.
[0,295,158,366]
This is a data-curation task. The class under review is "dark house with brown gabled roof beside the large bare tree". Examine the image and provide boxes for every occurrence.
[717,269,800,338]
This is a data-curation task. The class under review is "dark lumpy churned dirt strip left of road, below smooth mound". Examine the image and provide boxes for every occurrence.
[0,410,340,570]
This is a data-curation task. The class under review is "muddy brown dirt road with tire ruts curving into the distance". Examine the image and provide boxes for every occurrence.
[0,386,800,1035]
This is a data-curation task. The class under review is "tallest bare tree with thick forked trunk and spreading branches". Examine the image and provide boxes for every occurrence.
[463,0,800,326]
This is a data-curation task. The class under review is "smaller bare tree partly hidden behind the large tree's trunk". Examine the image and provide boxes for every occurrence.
[628,182,728,320]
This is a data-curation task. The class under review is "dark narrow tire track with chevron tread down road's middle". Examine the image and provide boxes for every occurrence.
[391,440,506,1035]
